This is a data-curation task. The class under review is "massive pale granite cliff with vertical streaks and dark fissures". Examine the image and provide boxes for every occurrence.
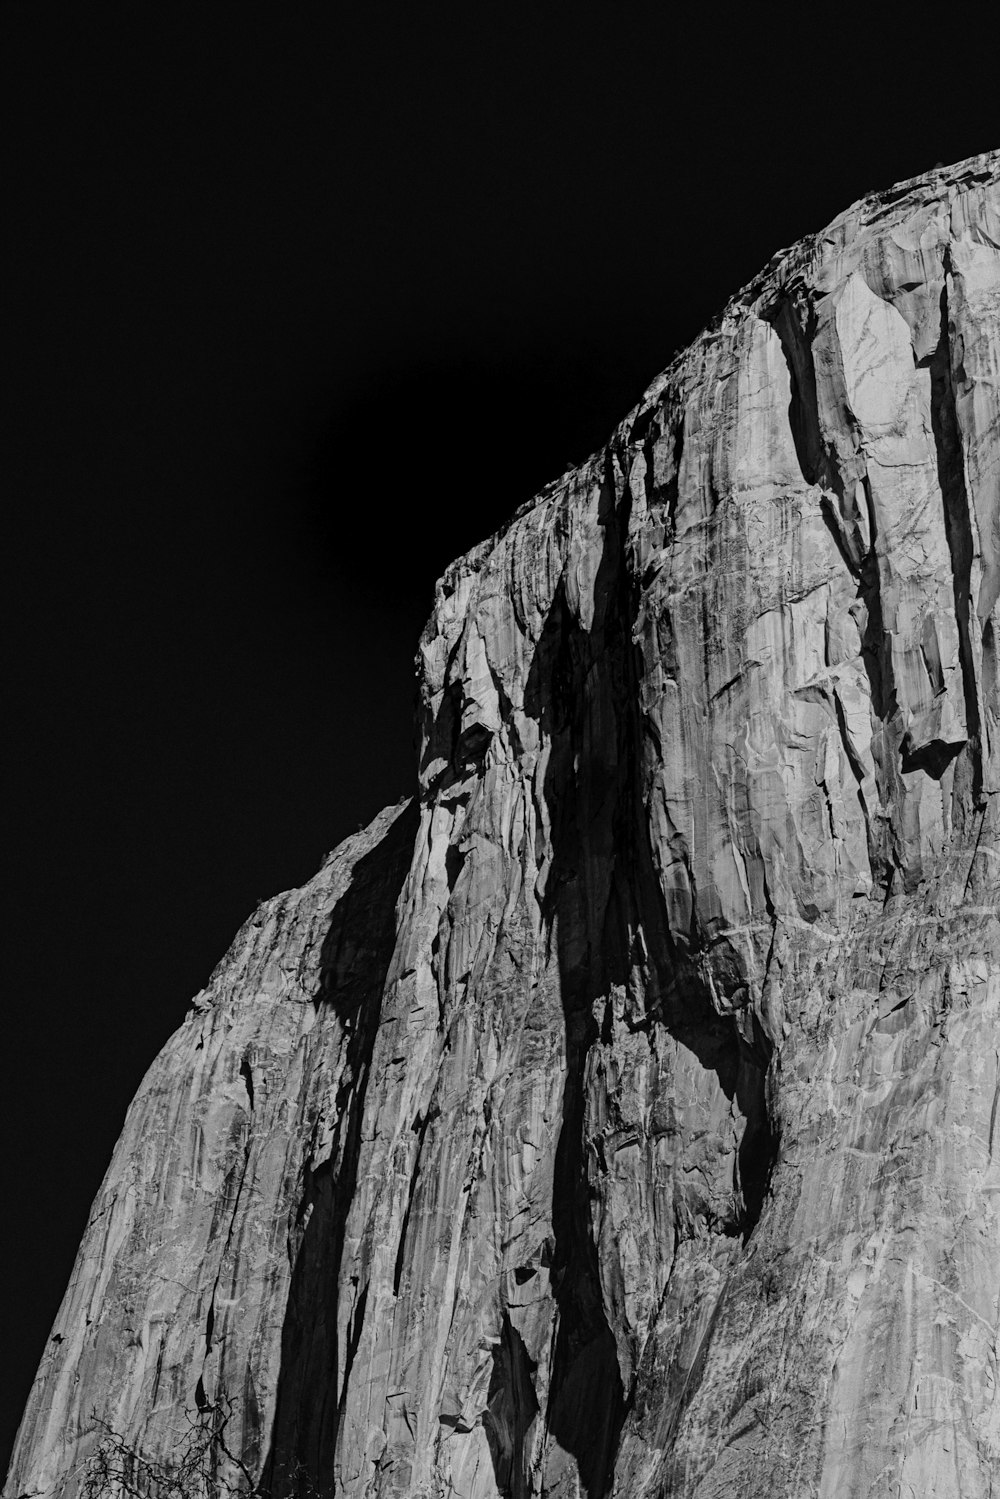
[6,156,1000,1499]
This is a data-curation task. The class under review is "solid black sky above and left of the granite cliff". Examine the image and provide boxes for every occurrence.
[0,0,1000,1465]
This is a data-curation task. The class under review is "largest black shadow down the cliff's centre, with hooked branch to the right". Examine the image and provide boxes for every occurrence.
[503,458,775,1499]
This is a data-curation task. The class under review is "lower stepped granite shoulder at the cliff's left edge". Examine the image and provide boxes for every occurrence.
[4,808,414,1495]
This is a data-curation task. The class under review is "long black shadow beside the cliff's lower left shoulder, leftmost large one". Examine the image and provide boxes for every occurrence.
[257,802,418,1499]
